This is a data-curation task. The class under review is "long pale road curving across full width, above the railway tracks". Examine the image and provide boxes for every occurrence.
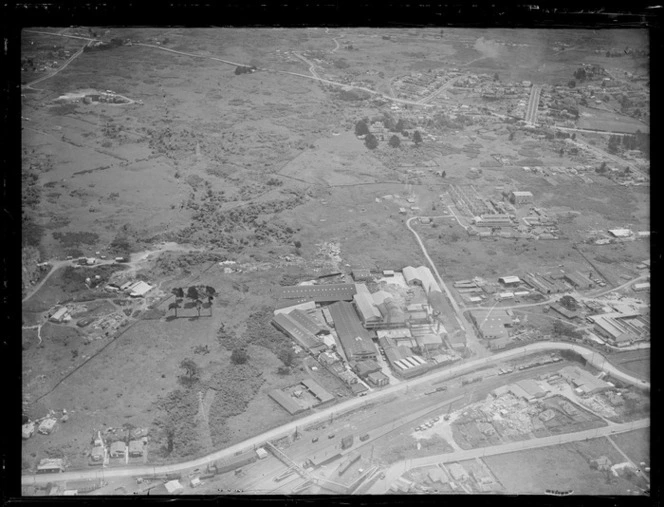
[21,342,650,485]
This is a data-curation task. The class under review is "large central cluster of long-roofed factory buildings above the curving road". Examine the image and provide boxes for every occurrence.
[272,266,465,394]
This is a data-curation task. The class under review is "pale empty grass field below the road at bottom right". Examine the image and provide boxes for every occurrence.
[484,444,634,495]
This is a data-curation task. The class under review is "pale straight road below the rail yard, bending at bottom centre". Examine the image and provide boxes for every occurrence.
[369,419,650,494]
